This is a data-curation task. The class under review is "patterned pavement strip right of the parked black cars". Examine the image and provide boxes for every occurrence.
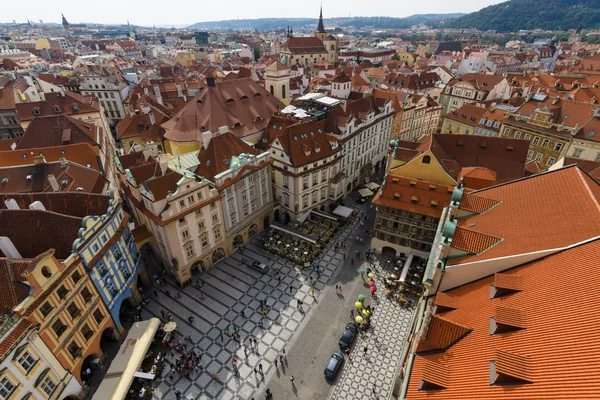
[329,256,414,400]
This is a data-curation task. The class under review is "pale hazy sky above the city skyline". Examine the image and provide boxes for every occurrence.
[0,0,504,26]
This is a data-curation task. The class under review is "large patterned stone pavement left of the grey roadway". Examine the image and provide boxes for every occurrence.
[142,208,364,400]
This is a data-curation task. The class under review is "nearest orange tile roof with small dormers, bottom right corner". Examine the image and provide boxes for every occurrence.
[406,239,600,400]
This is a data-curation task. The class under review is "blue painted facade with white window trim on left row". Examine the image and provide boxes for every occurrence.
[77,199,140,330]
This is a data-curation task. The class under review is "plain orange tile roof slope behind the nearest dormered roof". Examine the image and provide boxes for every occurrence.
[447,166,600,265]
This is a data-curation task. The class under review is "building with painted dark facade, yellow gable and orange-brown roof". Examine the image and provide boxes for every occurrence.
[372,134,528,257]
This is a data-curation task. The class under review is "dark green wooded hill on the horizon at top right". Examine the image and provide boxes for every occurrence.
[443,0,600,32]
